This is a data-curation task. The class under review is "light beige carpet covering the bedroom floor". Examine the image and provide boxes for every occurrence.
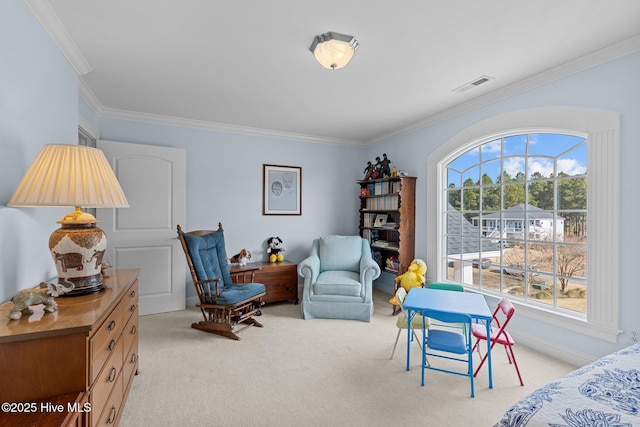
[120,291,574,427]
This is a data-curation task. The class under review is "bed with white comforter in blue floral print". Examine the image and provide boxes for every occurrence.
[494,343,640,427]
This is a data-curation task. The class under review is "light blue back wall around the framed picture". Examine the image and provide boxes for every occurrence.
[98,115,363,296]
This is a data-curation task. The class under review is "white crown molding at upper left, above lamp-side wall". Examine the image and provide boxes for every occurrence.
[23,0,92,76]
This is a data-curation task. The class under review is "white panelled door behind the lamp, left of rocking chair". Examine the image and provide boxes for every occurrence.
[96,141,187,315]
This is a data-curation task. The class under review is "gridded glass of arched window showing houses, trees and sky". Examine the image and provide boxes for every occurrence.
[444,132,588,315]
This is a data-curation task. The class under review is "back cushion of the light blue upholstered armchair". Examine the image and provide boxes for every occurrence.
[318,236,362,272]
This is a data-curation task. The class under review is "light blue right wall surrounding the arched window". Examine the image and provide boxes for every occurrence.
[368,53,640,362]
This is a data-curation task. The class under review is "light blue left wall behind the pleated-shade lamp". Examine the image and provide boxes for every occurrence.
[0,0,78,301]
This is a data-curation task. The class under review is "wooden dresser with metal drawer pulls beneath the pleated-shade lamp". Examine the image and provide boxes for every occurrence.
[0,269,139,427]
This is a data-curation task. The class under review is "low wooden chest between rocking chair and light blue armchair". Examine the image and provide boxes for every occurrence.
[229,261,298,304]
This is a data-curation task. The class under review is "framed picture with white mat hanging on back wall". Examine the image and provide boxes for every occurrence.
[262,164,302,215]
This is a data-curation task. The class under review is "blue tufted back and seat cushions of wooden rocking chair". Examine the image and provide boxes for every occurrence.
[183,230,265,305]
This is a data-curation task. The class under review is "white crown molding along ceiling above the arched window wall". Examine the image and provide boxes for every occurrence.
[366,35,640,145]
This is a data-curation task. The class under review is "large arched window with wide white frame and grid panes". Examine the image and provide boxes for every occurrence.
[427,107,620,342]
